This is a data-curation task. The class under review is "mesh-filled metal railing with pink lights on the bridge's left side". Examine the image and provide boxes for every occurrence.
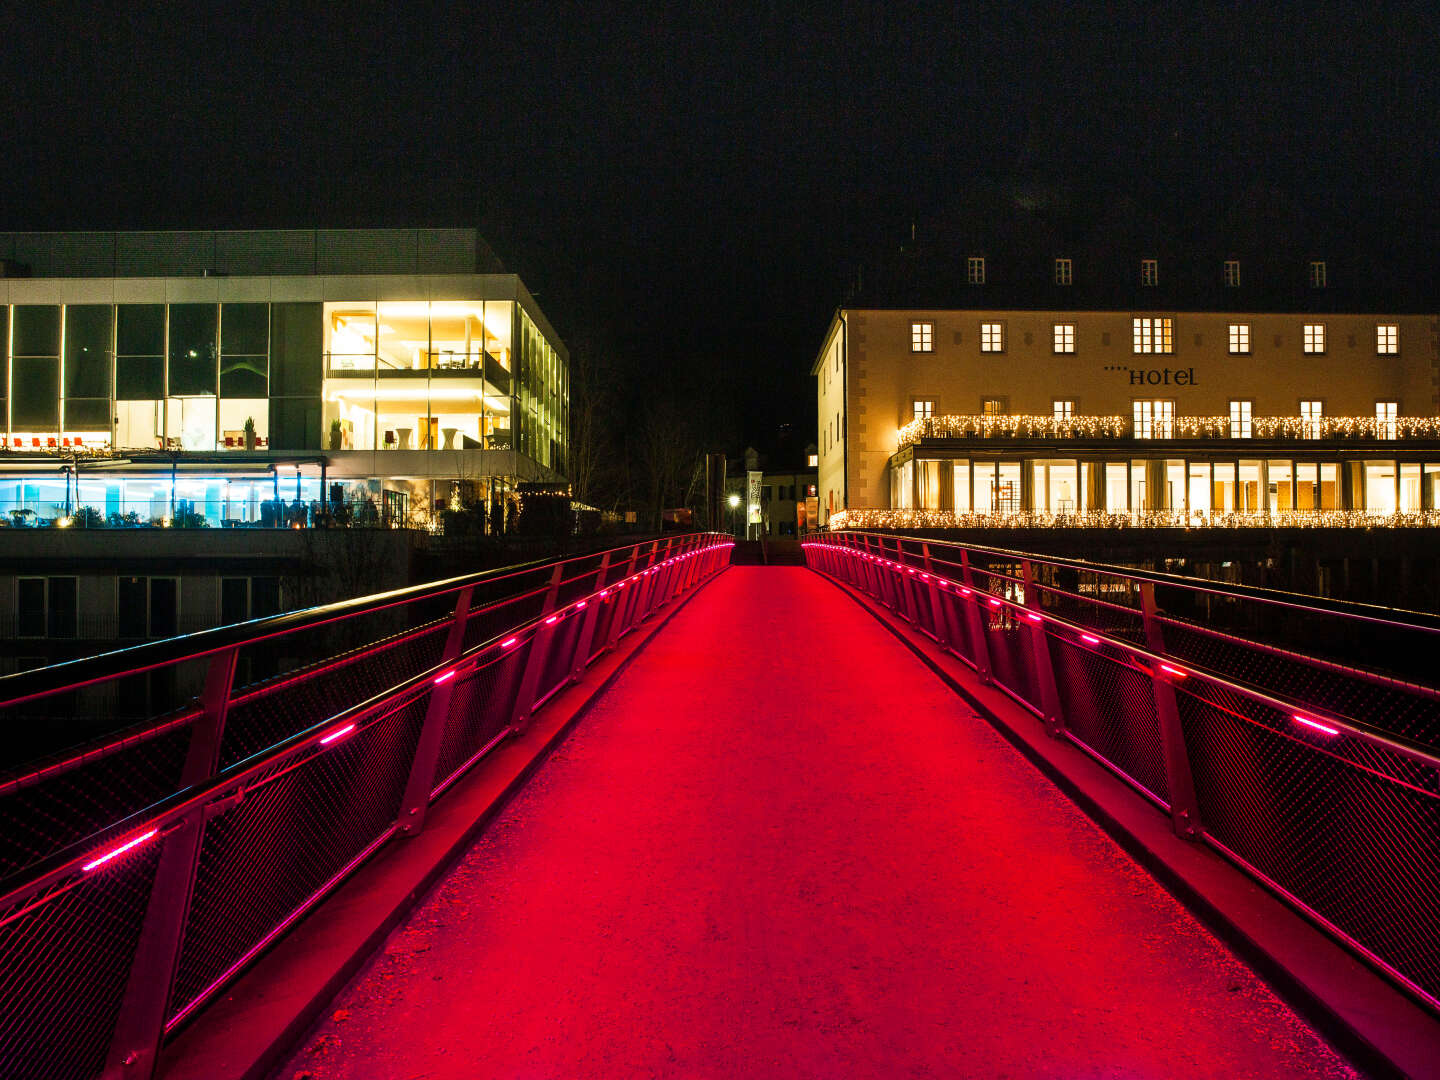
[0,534,733,1079]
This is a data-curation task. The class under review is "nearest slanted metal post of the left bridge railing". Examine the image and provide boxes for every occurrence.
[101,645,239,1080]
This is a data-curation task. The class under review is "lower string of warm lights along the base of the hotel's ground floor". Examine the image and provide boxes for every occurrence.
[827,508,1440,531]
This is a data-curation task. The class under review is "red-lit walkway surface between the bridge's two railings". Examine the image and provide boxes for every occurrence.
[275,566,1355,1080]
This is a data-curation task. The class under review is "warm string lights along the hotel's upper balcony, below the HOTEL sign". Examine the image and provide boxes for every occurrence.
[896,415,1440,451]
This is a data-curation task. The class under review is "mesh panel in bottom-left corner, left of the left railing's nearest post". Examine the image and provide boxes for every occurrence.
[0,844,160,1080]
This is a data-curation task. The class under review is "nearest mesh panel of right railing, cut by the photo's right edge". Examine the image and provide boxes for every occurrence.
[1176,683,1440,996]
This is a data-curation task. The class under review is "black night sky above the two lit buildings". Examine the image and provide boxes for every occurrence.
[0,3,1440,441]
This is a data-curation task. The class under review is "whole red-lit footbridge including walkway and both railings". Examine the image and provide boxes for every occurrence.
[0,533,1440,1079]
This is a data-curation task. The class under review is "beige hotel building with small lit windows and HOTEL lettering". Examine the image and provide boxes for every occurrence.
[812,253,1440,528]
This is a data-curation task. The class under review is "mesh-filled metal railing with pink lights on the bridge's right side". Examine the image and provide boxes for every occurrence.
[805,533,1440,1009]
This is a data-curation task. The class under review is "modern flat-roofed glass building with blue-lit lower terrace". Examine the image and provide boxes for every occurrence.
[0,229,570,527]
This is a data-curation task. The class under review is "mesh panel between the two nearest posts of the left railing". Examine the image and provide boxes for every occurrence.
[171,694,429,1011]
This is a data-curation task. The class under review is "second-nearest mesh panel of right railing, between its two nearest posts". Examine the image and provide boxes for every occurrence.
[1050,636,1169,804]
